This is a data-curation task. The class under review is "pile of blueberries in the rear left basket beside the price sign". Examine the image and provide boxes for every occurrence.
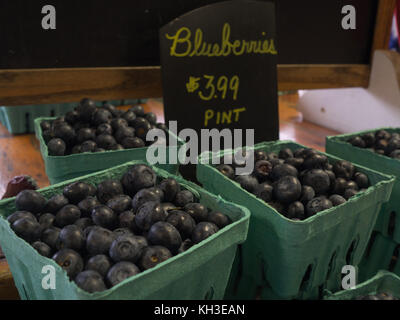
[40,98,167,156]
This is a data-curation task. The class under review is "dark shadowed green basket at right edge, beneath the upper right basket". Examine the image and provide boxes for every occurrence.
[359,231,400,281]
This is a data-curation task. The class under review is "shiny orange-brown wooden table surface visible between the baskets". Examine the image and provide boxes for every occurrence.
[0,94,337,300]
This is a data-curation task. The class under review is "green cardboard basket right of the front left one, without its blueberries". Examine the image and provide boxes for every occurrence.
[197,141,394,299]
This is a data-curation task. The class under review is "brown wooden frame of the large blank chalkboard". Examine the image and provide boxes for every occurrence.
[0,0,395,106]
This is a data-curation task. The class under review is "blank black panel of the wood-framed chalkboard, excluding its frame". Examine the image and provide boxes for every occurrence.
[0,0,378,69]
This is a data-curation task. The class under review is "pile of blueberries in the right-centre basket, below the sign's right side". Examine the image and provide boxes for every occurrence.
[216,148,370,221]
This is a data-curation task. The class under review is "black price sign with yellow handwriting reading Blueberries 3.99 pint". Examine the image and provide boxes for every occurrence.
[160,0,279,141]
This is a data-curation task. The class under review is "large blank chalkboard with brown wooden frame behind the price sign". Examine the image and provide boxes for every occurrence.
[0,0,395,105]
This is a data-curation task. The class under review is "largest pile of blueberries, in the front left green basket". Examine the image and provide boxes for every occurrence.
[7,164,231,293]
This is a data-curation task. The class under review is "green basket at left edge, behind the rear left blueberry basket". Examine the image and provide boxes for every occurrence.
[0,103,76,134]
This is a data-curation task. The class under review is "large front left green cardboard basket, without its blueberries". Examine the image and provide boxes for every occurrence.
[0,161,250,300]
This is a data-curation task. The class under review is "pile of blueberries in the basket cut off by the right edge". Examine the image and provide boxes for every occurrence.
[347,130,400,160]
